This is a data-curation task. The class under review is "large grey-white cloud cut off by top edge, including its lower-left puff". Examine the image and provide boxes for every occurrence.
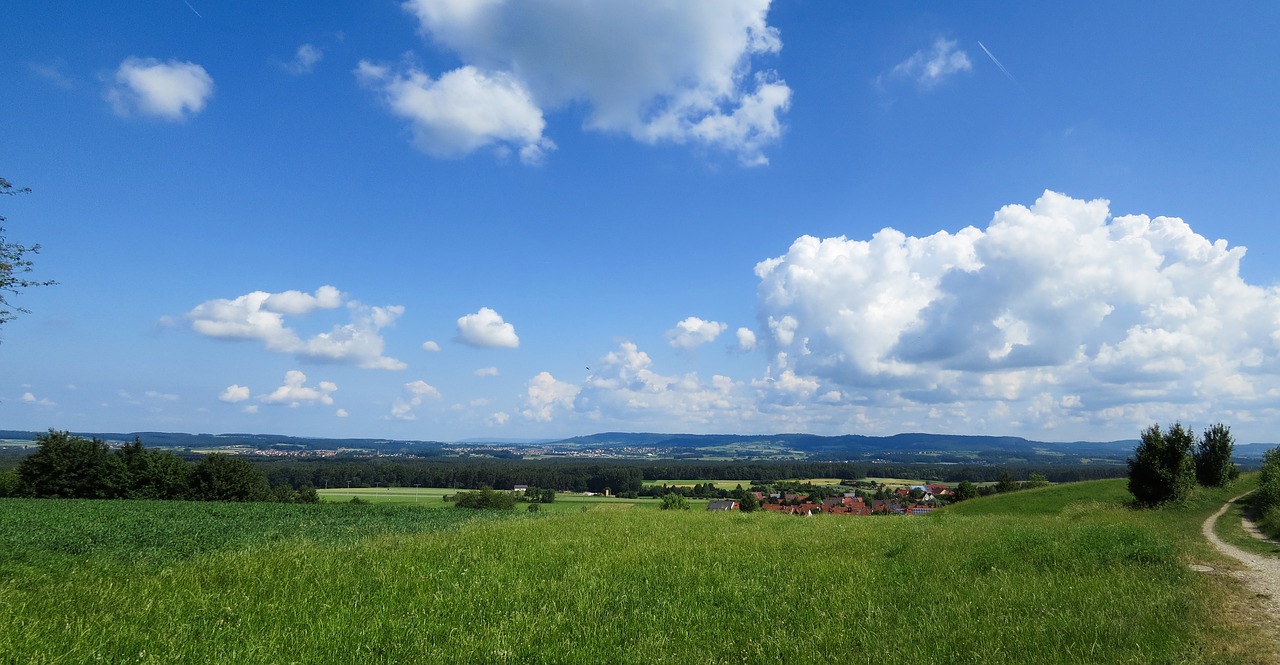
[357,0,791,165]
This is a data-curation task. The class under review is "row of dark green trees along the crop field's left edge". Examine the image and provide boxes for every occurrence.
[0,430,320,503]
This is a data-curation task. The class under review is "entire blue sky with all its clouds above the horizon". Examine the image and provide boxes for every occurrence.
[0,0,1280,441]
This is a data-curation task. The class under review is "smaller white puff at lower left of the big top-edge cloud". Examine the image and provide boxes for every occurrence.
[356,60,556,164]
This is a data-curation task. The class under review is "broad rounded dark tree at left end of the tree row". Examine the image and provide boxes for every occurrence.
[18,430,123,499]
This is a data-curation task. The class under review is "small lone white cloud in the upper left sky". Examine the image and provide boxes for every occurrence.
[106,56,214,121]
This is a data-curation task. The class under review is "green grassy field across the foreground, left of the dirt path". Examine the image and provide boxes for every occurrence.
[0,481,1275,664]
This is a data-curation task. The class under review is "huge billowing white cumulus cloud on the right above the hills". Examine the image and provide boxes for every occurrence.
[755,192,1280,427]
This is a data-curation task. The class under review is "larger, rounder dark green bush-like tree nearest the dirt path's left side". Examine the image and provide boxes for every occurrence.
[1129,422,1196,506]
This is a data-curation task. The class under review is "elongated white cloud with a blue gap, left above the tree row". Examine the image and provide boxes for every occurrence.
[187,286,406,370]
